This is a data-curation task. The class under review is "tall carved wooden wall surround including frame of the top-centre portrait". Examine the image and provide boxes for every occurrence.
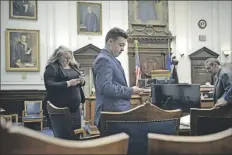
[127,1,175,86]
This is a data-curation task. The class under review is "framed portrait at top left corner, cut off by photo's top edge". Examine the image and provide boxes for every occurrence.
[9,0,38,20]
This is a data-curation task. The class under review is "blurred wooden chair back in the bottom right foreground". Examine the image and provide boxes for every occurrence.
[148,128,232,155]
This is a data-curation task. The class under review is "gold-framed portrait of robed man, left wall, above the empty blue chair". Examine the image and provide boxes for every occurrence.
[6,29,40,72]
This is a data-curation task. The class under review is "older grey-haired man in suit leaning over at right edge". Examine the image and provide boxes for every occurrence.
[205,58,232,107]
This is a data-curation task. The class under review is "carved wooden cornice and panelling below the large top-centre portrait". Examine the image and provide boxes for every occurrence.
[128,24,175,86]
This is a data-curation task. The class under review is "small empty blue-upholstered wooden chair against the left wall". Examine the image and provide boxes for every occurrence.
[22,101,43,130]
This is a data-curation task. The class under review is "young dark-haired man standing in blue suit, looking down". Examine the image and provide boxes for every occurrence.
[92,28,143,127]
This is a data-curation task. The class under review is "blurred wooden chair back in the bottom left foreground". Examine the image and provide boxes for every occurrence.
[0,121,129,155]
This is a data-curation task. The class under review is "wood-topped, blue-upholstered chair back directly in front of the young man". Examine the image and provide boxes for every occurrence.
[100,102,181,155]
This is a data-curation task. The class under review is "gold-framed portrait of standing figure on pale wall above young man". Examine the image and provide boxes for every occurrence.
[77,2,102,35]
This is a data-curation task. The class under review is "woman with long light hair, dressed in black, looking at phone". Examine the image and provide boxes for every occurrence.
[44,46,85,136]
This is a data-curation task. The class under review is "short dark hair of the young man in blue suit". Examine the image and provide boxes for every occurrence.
[105,27,128,43]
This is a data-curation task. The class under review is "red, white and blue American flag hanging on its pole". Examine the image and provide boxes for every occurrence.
[135,40,141,87]
